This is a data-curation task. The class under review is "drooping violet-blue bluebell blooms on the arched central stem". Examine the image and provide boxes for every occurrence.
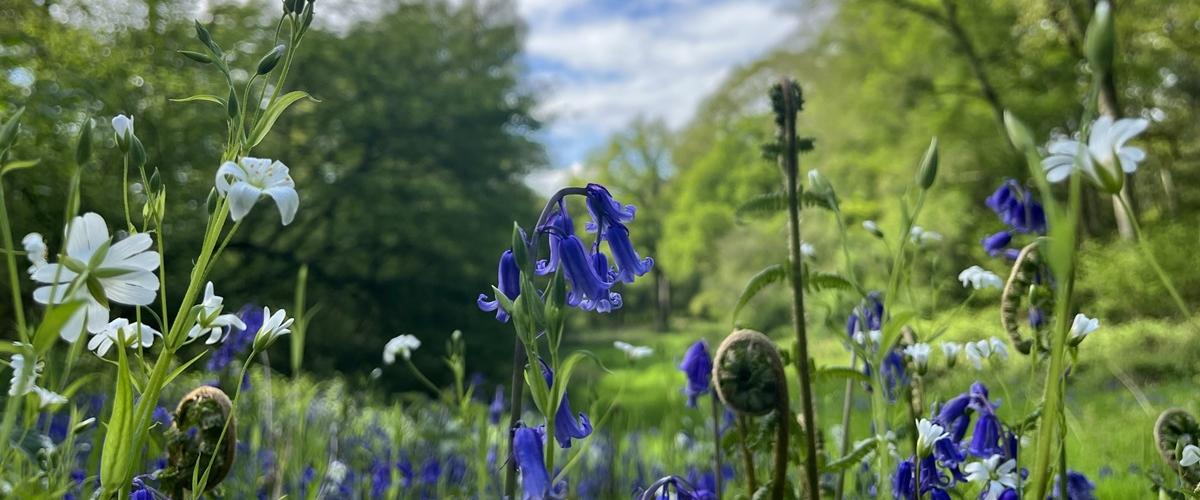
[476,183,654,321]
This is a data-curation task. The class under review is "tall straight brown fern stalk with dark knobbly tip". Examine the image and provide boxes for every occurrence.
[780,79,821,499]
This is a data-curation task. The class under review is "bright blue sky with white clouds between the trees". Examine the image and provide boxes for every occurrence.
[517,0,799,192]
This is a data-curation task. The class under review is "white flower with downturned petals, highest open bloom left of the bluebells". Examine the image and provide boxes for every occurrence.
[216,156,300,225]
